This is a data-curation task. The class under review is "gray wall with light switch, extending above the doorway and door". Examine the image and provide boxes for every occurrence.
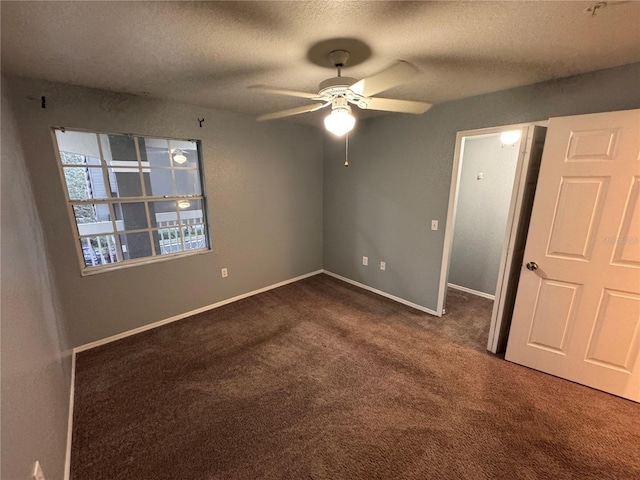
[323,63,640,310]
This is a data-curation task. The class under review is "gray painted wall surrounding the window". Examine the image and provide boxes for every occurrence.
[5,78,322,346]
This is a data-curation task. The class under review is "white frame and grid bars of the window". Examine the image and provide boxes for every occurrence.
[51,127,212,276]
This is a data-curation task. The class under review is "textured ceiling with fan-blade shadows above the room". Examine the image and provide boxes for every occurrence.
[1,1,640,121]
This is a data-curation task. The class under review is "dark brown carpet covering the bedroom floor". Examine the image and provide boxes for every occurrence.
[71,275,640,480]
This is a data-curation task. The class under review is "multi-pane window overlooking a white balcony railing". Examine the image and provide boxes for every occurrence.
[54,128,209,273]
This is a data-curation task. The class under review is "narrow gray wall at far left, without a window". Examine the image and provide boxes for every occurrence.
[0,79,71,480]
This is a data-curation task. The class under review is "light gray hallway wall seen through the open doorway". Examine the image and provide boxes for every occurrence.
[449,134,520,295]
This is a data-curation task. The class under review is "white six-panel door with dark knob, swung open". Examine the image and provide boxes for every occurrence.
[506,110,640,402]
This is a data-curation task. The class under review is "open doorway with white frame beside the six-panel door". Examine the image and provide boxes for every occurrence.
[438,124,545,353]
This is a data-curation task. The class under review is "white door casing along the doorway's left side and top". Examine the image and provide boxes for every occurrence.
[436,120,548,329]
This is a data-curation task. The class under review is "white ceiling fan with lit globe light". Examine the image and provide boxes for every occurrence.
[248,50,431,136]
